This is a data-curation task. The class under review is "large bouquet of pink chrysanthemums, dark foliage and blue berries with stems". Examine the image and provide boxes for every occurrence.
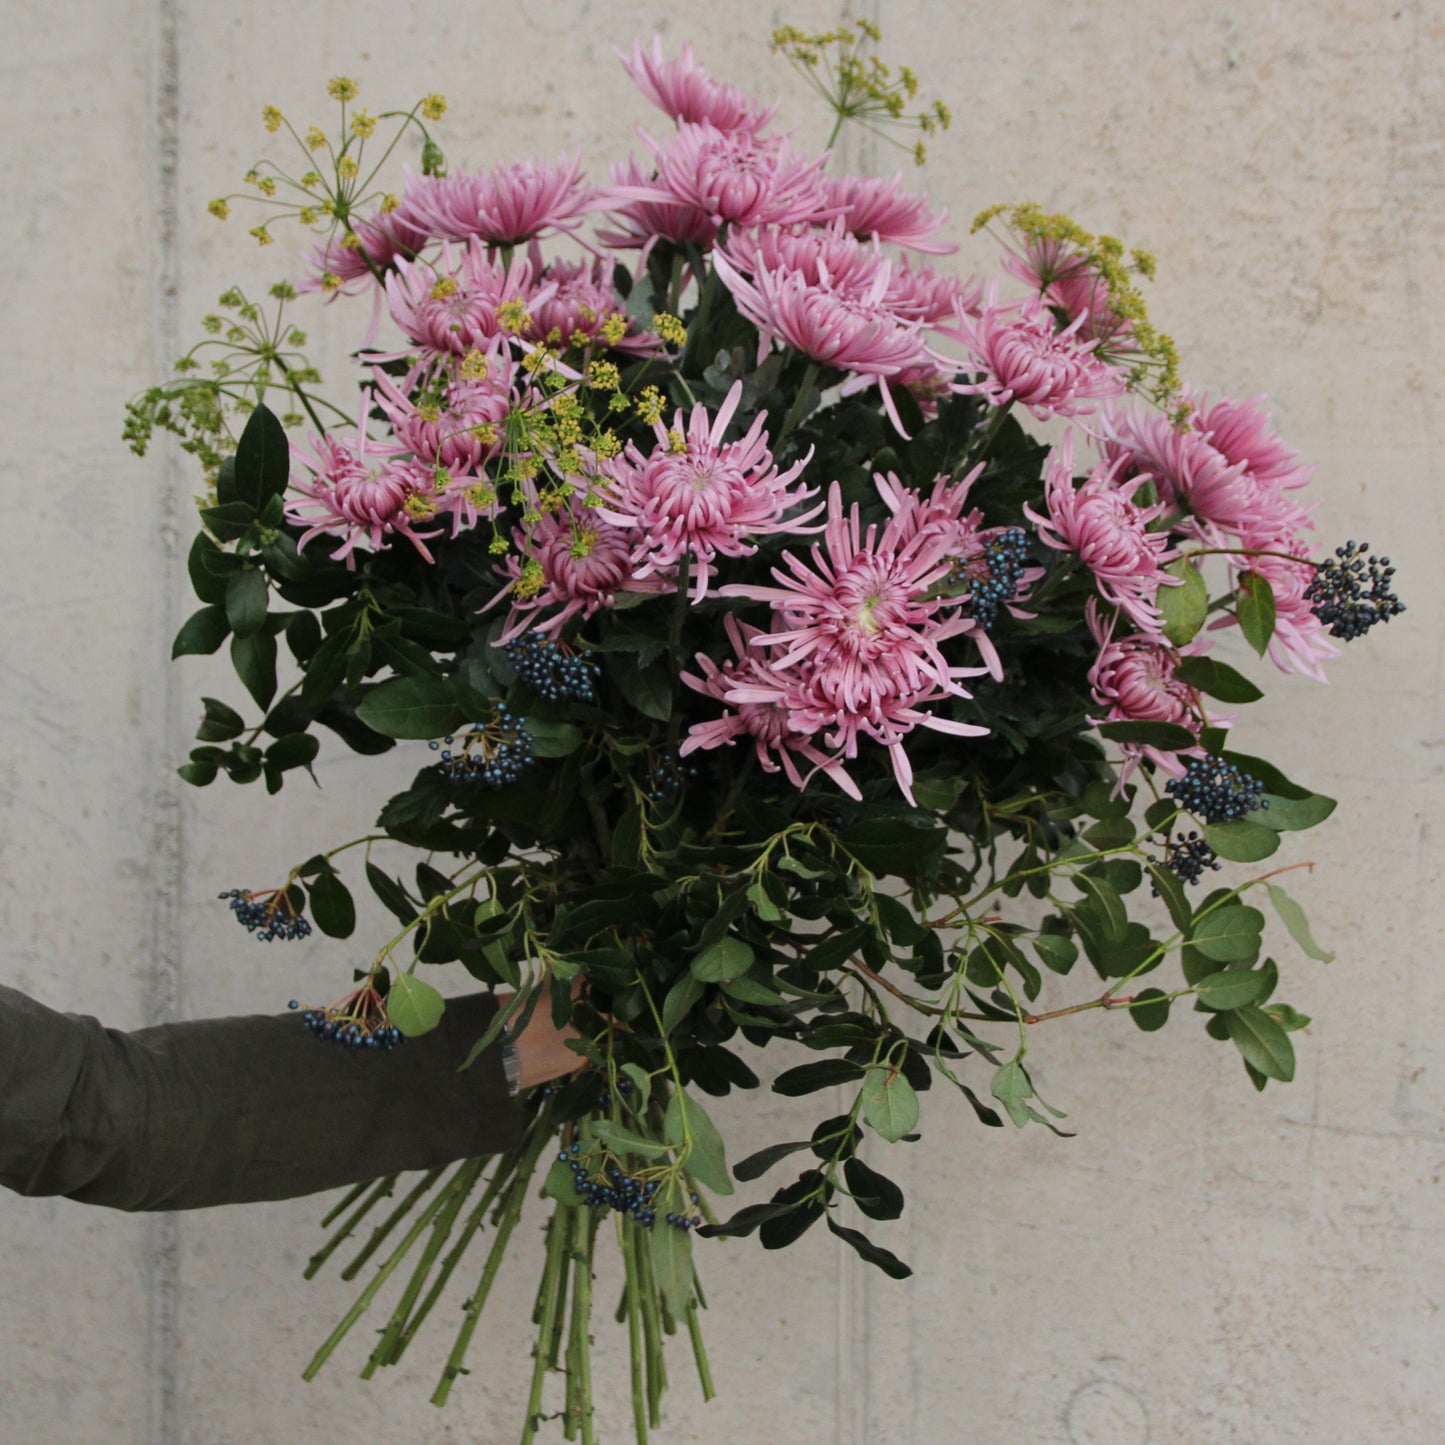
[127,22,1402,1441]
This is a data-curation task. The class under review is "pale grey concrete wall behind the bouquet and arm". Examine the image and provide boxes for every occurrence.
[0,0,1445,1445]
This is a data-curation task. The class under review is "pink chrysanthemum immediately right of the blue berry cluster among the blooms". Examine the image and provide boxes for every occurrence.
[1023,432,1175,634]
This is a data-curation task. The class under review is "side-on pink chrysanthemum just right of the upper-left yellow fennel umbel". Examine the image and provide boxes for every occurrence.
[403,156,595,246]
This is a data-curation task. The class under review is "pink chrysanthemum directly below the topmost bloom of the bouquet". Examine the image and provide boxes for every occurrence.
[624,123,824,225]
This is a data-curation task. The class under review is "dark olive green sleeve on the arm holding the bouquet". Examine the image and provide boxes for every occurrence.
[0,985,523,1209]
